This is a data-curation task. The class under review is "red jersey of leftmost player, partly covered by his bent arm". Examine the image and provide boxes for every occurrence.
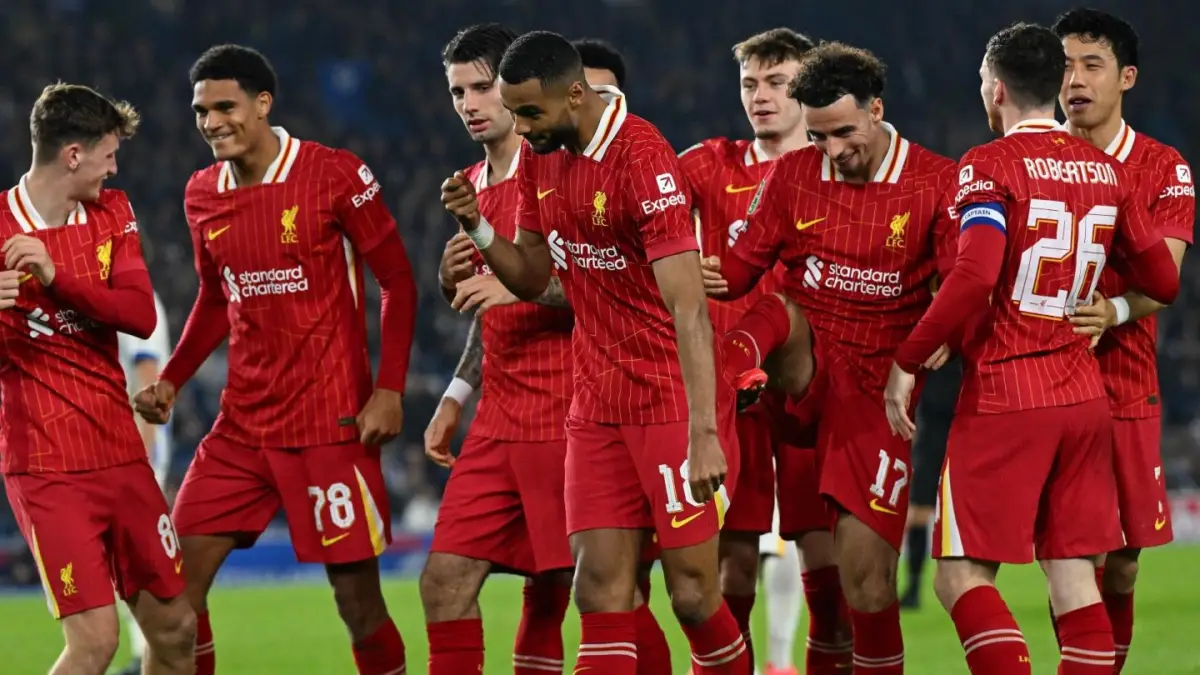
[0,178,146,473]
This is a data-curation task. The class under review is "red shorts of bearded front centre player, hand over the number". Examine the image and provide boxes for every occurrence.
[566,414,740,549]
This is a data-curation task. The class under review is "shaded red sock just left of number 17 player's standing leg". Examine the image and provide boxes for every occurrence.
[800,566,854,675]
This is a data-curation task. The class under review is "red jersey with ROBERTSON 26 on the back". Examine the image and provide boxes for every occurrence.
[955,120,1159,413]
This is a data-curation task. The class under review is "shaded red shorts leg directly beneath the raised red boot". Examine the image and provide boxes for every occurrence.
[722,392,782,534]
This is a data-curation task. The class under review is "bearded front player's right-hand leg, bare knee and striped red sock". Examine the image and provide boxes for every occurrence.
[661,536,754,675]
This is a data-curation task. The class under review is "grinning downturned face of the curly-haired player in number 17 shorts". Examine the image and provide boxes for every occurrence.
[802,94,883,180]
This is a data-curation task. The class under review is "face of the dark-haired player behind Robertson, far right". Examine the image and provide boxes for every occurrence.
[1058,35,1138,129]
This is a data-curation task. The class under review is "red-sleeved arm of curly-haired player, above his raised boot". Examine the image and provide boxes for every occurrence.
[721,170,791,300]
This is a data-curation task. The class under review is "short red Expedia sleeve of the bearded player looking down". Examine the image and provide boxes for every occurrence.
[625,143,700,262]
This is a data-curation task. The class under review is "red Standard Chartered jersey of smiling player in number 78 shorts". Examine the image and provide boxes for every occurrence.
[176,127,396,448]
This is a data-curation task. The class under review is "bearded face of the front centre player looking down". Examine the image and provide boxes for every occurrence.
[500,78,584,155]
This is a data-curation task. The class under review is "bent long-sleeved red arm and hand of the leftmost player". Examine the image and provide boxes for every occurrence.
[19,195,158,338]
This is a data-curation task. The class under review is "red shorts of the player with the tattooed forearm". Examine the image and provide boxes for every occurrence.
[431,434,575,574]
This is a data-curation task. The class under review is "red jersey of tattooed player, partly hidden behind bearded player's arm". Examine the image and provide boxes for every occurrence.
[467,154,575,442]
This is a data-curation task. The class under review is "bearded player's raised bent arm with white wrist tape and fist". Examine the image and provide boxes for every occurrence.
[442,158,552,301]
